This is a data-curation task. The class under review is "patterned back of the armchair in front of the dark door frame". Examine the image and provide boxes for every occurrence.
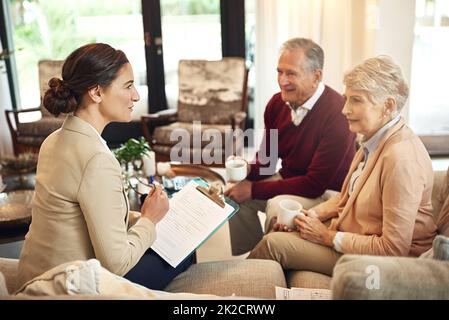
[178,58,247,124]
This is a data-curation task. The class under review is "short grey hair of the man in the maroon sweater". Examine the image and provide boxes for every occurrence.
[280,38,324,71]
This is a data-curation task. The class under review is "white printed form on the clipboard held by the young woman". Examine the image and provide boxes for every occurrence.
[151,179,239,268]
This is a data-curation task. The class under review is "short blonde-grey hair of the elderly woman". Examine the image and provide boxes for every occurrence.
[343,56,409,111]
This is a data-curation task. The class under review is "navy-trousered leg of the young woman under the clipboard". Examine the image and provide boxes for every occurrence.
[124,249,195,290]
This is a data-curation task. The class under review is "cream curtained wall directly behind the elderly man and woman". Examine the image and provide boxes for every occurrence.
[254,0,416,136]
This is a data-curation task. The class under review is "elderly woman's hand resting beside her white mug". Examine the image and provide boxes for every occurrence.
[295,211,337,247]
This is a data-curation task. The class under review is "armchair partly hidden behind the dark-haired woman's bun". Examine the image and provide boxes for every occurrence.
[5,60,64,155]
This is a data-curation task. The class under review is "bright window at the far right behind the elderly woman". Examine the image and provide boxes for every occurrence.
[410,0,449,136]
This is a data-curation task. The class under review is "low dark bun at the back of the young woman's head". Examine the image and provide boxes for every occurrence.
[43,78,77,116]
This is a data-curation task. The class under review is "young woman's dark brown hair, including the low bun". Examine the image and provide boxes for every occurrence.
[43,43,129,116]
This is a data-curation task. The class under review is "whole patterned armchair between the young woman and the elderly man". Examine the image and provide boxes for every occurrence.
[141,58,248,165]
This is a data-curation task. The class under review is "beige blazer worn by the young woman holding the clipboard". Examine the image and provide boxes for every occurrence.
[19,116,156,283]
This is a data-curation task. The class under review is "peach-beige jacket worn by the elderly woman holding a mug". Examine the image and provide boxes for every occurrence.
[329,119,436,256]
